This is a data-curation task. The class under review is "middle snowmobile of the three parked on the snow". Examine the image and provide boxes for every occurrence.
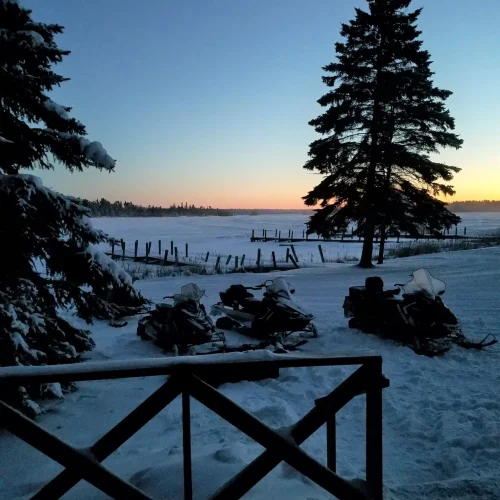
[211,278,318,343]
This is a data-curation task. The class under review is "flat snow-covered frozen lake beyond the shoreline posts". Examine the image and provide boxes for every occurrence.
[93,213,500,264]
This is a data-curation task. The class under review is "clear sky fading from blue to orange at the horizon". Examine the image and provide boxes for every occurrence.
[22,0,500,208]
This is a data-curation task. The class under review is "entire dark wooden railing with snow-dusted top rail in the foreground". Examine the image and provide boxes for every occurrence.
[0,351,389,500]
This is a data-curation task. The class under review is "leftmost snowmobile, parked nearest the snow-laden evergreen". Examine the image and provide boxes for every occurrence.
[137,283,224,354]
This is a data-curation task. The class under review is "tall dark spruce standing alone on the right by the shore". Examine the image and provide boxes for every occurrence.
[303,0,462,267]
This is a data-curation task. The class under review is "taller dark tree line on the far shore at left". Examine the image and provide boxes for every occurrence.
[81,198,233,217]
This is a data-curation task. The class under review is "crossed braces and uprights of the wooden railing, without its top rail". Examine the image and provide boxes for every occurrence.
[0,356,388,500]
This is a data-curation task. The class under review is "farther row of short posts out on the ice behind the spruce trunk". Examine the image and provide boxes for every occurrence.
[250,226,467,243]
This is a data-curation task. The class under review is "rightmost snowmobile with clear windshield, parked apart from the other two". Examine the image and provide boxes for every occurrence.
[343,268,497,356]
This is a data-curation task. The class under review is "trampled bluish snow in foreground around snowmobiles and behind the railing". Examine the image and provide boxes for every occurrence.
[0,245,500,500]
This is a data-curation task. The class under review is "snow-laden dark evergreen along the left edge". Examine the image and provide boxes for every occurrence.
[0,0,144,414]
